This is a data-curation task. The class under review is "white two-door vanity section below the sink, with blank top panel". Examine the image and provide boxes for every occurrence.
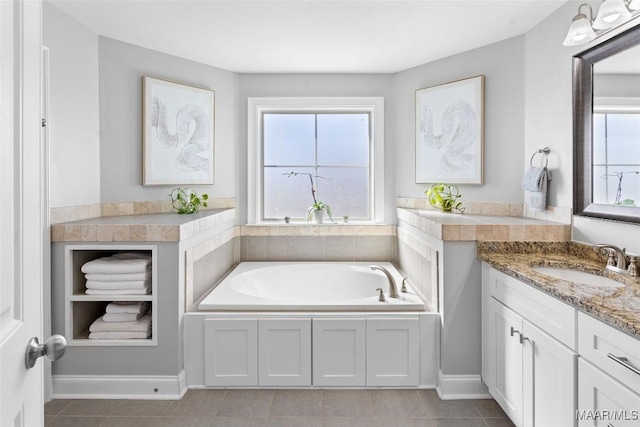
[482,264,577,426]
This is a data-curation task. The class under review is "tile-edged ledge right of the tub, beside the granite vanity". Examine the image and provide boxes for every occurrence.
[398,208,571,241]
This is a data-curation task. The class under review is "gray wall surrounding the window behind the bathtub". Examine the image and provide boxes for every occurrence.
[238,74,397,224]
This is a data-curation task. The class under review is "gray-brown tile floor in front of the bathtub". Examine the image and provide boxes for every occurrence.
[45,390,513,427]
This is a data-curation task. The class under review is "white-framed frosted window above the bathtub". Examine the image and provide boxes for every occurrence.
[249,98,383,223]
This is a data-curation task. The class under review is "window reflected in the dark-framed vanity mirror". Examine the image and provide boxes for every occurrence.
[593,100,640,206]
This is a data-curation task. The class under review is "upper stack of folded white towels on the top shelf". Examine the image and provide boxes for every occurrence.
[80,252,151,295]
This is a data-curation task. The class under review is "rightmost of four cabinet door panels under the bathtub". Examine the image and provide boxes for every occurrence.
[367,318,420,386]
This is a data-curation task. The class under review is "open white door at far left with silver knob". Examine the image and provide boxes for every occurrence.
[0,0,45,427]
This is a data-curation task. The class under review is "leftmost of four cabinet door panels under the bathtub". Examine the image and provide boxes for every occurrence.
[204,319,258,386]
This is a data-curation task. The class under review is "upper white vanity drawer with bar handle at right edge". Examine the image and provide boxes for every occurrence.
[578,313,640,394]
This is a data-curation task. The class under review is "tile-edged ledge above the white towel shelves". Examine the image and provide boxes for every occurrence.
[51,208,236,242]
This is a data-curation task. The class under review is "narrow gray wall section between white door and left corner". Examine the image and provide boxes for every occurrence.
[42,2,100,208]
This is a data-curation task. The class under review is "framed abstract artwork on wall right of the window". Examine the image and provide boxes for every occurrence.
[415,75,484,184]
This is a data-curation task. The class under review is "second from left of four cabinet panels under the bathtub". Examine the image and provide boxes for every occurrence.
[258,319,311,386]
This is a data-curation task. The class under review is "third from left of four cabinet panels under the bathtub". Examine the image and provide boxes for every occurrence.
[313,319,366,386]
